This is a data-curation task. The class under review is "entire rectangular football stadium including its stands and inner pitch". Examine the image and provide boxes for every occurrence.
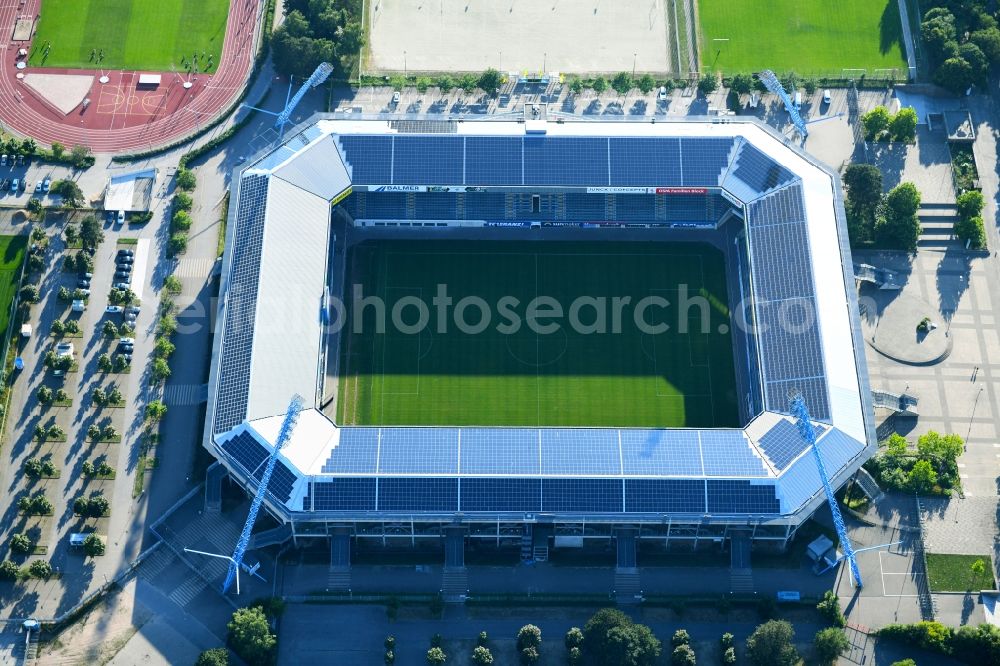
[204,107,876,566]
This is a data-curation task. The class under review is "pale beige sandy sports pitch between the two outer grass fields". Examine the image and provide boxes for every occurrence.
[367,0,672,73]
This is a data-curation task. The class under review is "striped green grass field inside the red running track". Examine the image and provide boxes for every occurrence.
[29,0,229,71]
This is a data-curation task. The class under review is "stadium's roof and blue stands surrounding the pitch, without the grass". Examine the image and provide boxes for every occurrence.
[204,113,875,547]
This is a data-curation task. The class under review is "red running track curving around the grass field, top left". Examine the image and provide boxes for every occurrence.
[0,0,263,153]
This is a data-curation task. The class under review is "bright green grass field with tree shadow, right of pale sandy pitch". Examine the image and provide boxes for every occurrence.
[698,0,906,77]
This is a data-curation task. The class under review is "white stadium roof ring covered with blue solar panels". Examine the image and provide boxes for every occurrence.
[207,111,874,515]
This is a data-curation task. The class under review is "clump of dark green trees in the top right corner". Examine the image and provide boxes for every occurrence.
[920,0,1000,94]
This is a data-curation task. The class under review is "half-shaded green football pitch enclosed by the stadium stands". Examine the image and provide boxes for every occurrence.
[337,241,738,427]
